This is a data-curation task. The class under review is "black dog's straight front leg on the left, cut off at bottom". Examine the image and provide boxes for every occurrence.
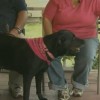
[23,74,33,100]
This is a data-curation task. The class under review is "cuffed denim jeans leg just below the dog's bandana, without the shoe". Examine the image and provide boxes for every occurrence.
[47,57,68,90]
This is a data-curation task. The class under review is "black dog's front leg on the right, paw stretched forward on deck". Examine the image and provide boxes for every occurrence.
[35,71,47,100]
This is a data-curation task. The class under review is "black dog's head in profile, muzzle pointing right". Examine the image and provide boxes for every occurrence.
[54,30,84,57]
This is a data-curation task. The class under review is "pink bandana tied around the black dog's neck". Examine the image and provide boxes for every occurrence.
[26,38,54,64]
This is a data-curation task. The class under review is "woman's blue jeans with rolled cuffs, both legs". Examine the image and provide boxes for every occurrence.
[47,38,99,90]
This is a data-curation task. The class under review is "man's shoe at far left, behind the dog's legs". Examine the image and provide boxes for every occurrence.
[9,87,23,98]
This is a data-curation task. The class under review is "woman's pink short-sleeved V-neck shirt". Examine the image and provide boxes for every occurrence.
[43,0,100,39]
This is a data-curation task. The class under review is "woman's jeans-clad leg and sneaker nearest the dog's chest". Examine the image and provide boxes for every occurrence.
[47,57,70,100]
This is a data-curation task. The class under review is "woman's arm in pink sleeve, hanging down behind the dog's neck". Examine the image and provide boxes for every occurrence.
[43,0,58,35]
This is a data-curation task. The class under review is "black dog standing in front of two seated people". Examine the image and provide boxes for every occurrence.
[0,30,84,100]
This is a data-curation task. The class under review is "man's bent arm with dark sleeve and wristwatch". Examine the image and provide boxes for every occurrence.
[10,0,28,37]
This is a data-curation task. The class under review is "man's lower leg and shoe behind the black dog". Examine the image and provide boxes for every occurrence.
[8,71,23,98]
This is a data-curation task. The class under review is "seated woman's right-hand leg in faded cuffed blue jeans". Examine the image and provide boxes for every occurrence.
[72,38,98,95]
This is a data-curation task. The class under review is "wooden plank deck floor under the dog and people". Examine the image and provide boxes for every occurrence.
[0,71,100,100]
